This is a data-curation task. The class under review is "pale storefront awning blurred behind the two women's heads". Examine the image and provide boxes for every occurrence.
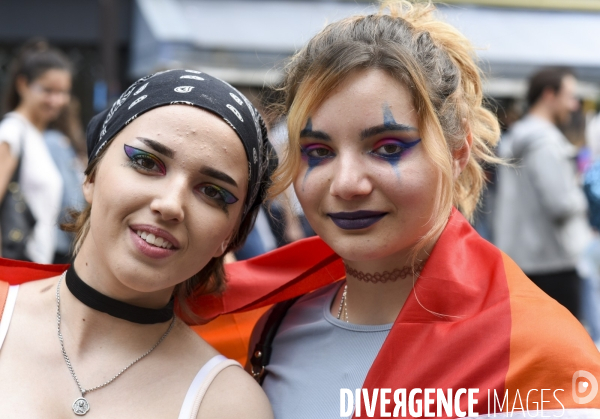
[130,0,600,97]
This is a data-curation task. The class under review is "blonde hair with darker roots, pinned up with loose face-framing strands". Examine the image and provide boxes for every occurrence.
[270,0,500,254]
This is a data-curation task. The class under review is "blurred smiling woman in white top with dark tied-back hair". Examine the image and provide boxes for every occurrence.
[0,40,71,263]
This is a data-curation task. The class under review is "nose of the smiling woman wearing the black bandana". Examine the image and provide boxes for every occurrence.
[150,179,189,223]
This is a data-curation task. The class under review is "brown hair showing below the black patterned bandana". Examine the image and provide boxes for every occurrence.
[61,120,270,323]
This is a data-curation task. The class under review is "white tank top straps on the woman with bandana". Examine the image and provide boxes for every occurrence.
[0,285,241,419]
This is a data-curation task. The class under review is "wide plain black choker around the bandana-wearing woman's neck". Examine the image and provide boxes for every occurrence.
[65,265,174,324]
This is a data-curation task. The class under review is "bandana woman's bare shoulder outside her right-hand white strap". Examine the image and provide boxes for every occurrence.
[198,366,273,419]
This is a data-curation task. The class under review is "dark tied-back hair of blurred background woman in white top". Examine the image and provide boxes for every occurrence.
[2,38,73,113]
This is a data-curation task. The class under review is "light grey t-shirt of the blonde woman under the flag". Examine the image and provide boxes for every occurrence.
[263,283,392,419]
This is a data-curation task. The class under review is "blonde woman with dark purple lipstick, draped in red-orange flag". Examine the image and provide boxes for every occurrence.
[188,1,600,419]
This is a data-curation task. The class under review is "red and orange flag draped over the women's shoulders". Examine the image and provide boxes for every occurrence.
[0,210,600,417]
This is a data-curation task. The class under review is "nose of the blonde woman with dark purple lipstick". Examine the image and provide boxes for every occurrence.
[329,155,373,200]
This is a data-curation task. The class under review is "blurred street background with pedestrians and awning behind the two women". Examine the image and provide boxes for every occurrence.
[0,0,600,342]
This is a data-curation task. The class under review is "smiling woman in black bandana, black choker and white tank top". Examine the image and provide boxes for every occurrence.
[0,70,275,419]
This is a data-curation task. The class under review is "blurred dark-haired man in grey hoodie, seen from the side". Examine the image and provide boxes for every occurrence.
[494,67,591,316]
